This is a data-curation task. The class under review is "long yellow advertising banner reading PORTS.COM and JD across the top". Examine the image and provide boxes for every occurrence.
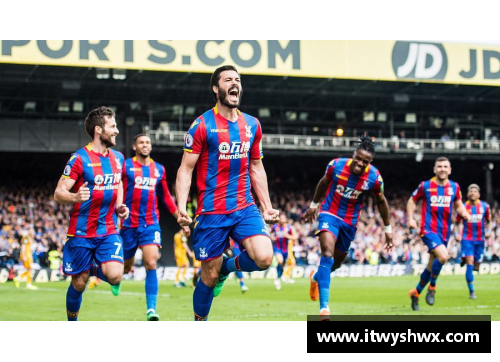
[0,40,500,86]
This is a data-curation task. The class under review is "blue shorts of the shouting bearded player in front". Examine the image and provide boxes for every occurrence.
[193,205,270,261]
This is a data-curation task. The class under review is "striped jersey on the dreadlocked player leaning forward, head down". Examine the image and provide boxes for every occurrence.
[320,158,384,227]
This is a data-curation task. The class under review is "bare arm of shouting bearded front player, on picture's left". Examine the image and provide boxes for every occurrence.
[175,152,200,226]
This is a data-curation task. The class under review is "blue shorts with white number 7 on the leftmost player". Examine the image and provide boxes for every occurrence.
[63,234,123,275]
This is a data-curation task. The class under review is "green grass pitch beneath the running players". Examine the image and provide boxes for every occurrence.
[0,275,500,321]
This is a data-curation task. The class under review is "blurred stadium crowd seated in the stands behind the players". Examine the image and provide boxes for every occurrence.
[0,185,500,268]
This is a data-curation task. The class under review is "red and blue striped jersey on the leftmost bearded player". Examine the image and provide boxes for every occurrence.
[62,143,124,238]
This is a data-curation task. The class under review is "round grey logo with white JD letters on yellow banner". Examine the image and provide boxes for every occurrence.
[392,41,448,79]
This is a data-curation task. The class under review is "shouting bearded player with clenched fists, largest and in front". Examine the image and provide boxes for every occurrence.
[176,65,279,320]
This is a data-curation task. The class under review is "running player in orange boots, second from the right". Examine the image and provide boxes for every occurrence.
[406,157,470,310]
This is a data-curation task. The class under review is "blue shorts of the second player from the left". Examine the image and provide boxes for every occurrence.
[120,224,161,260]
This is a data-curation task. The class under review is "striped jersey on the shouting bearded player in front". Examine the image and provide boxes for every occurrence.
[184,106,263,215]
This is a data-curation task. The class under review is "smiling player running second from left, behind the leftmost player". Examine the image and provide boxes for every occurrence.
[120,133,190,321]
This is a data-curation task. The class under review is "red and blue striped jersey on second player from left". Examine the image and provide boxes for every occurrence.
[122,157,177,228]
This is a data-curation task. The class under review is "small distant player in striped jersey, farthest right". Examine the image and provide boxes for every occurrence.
[456,184,491,299]
